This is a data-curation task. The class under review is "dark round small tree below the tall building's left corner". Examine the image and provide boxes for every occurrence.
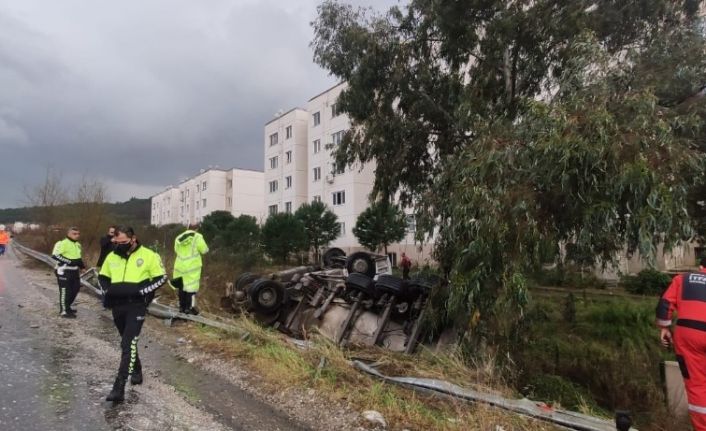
[262,213,306,263]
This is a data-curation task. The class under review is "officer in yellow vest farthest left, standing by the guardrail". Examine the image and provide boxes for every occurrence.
[52,227,86,318]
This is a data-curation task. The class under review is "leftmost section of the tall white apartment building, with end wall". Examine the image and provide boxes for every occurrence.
[260,108,309,215]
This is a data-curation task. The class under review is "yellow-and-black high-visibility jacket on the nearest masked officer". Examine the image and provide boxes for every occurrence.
[98,244,167,308]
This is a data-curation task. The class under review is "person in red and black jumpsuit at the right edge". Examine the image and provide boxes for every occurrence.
[657,258,706,431]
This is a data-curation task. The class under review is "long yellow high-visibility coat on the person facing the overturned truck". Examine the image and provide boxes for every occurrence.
[173,230,208,293]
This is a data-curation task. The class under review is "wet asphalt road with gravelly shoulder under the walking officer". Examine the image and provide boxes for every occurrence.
[0,253,306,431]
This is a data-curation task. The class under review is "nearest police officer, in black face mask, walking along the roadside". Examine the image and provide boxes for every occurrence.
[99,226,167,402]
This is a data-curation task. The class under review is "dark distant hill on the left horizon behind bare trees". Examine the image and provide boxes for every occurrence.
[0,198,150,226]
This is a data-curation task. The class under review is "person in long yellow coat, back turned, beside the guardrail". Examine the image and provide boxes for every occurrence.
[172,225,208,314]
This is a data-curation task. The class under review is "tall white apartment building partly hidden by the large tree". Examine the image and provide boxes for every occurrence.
[264,83,431,262]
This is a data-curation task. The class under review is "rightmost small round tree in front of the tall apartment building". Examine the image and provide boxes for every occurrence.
[353,201,407,254]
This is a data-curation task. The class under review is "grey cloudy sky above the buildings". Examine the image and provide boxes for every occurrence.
[0,0,398,208]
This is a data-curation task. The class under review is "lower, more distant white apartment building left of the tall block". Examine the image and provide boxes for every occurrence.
[151,168,263,226]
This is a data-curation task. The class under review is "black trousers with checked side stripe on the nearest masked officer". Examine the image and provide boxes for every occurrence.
[112,302,147,380]
